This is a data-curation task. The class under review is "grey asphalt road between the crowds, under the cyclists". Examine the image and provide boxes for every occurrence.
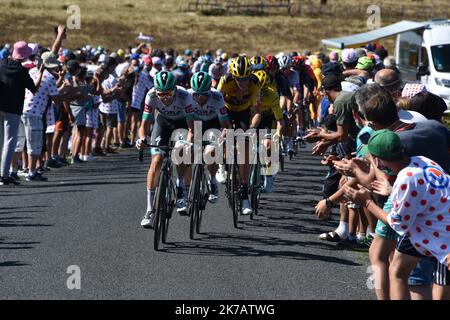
[0,146,374,300]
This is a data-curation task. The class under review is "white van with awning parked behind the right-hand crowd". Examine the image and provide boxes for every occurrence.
[395,20,450,108]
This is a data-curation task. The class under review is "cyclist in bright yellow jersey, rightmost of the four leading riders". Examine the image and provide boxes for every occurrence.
[254,70,284,192]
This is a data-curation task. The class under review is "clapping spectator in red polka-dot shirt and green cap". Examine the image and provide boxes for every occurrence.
[345,129,450,299]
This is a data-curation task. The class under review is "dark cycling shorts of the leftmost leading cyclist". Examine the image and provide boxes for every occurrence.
[150,114,188,155]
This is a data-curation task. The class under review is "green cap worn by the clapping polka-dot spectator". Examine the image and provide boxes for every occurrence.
[368,129,404,160]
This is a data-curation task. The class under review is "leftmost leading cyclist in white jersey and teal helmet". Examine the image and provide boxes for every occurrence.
[136,71,194,228]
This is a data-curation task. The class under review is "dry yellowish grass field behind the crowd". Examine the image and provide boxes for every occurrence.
[0,0,450,54]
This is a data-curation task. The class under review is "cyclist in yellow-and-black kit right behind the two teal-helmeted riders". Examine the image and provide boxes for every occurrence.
[217,56,261,214]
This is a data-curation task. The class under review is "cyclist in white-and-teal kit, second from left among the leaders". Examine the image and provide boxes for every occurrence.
[188,71,231,203]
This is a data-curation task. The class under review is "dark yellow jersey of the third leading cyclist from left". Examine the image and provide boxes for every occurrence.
[217,74,261,112]
